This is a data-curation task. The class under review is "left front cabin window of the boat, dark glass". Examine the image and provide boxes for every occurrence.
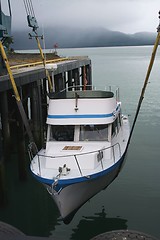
[49,125,74,141]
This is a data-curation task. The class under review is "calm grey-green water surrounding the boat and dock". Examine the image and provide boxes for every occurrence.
[0,47,160,240]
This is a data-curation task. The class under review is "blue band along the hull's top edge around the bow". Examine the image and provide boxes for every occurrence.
[32,154,125,191]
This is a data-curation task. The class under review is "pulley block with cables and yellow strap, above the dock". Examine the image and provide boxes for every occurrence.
[23,0,53,92]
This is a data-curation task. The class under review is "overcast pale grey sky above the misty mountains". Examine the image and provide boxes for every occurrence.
[1,0,160,33]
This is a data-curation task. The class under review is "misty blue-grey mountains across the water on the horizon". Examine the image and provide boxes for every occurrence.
[12,26,156,50]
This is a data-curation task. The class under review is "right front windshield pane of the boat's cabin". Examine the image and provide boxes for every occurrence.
[79,124,108,141]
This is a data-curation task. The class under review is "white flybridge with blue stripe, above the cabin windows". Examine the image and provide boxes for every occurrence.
[47,90,120,125]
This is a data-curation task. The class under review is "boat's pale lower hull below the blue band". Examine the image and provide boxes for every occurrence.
[45,156,124,223]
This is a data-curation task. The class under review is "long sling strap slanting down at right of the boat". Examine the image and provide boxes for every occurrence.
[127,11,160,148]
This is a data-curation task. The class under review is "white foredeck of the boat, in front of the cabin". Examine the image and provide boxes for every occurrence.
[31,142,121,180]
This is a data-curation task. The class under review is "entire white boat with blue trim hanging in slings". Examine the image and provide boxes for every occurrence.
[29,86,130,223]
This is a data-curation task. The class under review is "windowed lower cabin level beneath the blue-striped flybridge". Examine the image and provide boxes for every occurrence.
[47,109,122,142]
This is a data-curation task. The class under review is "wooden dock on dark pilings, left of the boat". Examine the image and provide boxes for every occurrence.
[0,56,92,205]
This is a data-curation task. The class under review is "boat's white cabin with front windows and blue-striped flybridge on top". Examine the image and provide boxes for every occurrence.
[47,90,121,147]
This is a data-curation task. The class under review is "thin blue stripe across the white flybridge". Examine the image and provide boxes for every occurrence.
[48,113,113,119]
